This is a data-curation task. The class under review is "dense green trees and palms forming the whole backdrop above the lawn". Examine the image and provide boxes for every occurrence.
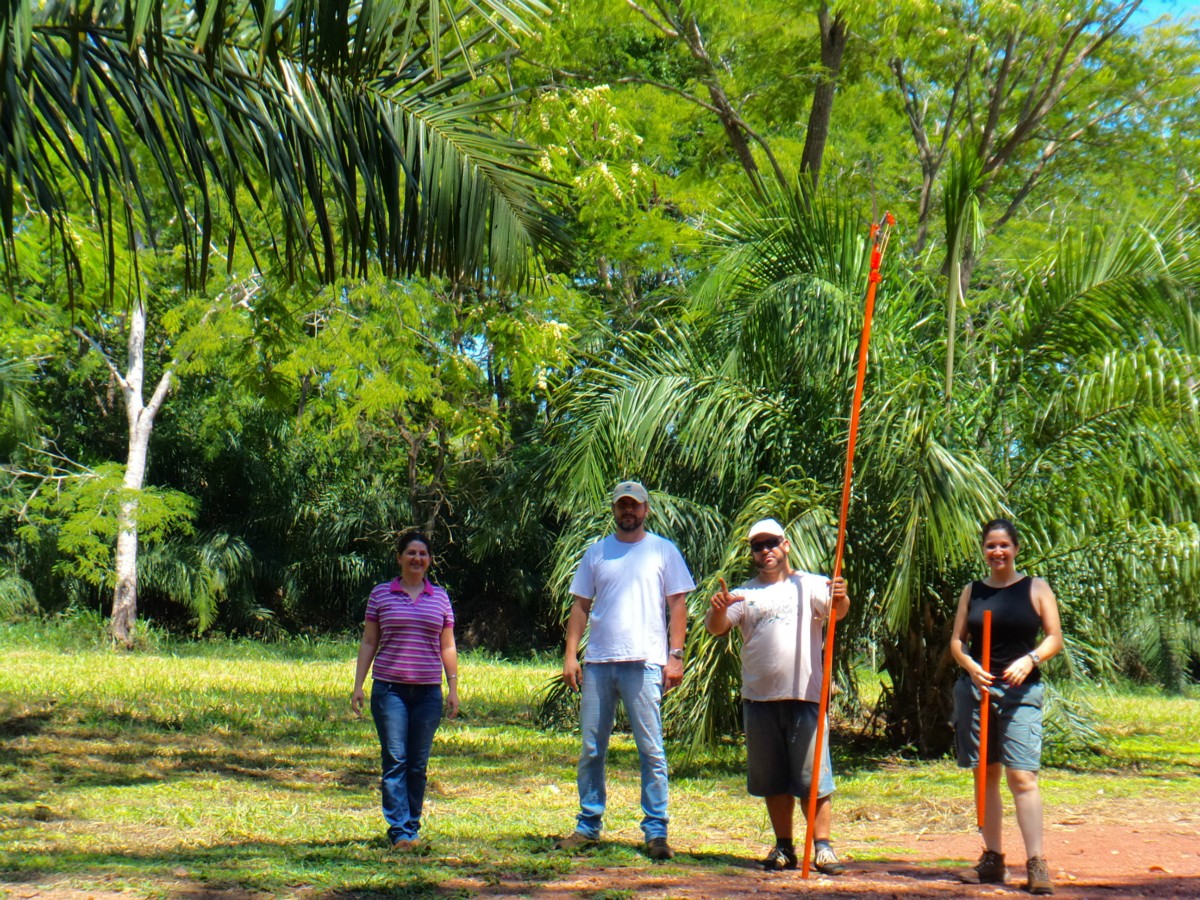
[0,0,1200,752]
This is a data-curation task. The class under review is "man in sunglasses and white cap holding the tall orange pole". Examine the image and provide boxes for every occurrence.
[704,518,850,875]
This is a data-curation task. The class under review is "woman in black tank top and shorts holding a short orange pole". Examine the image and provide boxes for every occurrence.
[950,518,1062,894]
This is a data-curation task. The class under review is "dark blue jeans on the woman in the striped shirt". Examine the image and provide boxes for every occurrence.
[371,680,442,844]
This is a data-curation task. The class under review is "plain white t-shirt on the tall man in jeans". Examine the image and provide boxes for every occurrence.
[571,532,696,666]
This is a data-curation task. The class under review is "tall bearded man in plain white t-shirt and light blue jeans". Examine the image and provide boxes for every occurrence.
[554,481,696,859]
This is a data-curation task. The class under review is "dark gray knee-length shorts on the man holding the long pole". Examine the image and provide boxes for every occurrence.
[742,700,834,797]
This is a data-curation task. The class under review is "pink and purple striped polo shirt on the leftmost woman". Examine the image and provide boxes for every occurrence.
[366,578,454,684]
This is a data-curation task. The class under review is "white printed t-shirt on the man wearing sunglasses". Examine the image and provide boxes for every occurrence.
[727,572,829,703]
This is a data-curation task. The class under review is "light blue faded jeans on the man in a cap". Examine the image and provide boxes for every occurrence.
[575,662,667,840]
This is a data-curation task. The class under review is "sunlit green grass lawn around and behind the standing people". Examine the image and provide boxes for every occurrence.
[0,624,1200,896]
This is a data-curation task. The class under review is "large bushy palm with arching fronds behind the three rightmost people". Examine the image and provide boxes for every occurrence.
[551,181,1200,754]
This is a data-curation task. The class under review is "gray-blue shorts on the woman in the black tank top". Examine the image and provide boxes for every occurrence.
[954,674,1045,772]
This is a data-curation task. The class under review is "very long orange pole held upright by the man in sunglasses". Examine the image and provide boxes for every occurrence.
[800,212,896,878]
